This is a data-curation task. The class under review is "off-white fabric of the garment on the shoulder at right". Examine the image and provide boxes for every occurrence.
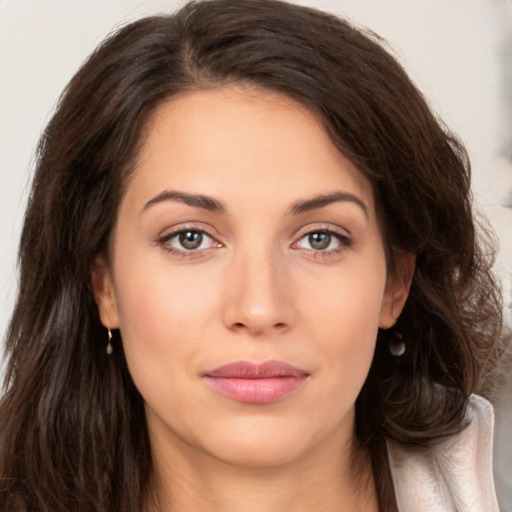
[387,395,499,512]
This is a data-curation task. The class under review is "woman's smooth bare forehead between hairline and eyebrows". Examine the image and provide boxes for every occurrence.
[123,86,373,215]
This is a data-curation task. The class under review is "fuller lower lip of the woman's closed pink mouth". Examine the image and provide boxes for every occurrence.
[205,375,307,404]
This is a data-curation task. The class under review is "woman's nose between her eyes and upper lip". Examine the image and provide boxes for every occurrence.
[223,250,294,336]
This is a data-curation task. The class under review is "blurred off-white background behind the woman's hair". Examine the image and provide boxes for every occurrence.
[0,0,512,511]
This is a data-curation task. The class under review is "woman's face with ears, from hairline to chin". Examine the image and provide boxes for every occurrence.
[93,87,412,465]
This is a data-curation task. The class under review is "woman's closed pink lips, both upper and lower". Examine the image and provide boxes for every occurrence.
[203,361,309,404]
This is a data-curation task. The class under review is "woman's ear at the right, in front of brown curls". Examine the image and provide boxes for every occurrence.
[379,252,416,329]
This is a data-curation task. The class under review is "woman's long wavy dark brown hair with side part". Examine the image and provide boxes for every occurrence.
[0,0,501,512]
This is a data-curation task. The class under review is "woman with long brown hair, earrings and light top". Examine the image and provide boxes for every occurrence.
[0,0,500,512]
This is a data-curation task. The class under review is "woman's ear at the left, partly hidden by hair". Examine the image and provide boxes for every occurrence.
[91,255,119,329]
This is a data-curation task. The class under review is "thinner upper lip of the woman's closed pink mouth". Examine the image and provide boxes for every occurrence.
[204,361,309,379]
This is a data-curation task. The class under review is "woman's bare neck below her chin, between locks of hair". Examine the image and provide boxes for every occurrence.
[143,428,378,512]
